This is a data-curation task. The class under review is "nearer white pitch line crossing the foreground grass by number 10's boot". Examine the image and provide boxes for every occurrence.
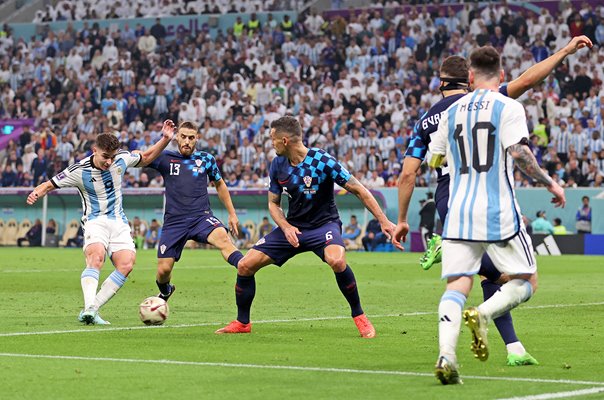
[0,353,604,393]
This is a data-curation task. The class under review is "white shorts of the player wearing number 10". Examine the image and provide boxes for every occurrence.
[441,229,537,279]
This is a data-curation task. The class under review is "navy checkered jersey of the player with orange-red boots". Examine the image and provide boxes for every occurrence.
[269,148,351,229]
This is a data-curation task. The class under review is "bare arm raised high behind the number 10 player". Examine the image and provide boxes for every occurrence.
[507,36,593,99]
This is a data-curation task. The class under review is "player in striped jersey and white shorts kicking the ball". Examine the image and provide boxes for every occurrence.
[27,120,175,325]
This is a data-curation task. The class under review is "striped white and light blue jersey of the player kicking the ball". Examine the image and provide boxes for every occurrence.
[50,151,141,223]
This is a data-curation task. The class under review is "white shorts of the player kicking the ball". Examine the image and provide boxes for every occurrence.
[84,218,136,255]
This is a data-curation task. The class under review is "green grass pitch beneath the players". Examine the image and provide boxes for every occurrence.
[0,248,604,400]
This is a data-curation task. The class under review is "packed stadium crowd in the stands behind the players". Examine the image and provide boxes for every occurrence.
[0,1,604,188]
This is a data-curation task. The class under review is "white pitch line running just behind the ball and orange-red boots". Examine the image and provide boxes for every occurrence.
[0,302,604,337]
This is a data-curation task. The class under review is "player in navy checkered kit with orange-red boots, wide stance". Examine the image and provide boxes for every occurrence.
[216,116,395,338]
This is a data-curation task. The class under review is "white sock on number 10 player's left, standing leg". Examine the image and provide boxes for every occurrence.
[438,290,466,364]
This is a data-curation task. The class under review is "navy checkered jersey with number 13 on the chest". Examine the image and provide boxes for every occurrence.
[149,151,222,220]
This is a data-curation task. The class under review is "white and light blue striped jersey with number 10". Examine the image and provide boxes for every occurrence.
[430,89,528,242]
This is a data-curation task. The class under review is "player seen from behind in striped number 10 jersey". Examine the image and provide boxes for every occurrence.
[430,46,566,384]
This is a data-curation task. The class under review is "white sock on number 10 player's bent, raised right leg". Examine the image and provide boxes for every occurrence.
[478,279,533,321]
